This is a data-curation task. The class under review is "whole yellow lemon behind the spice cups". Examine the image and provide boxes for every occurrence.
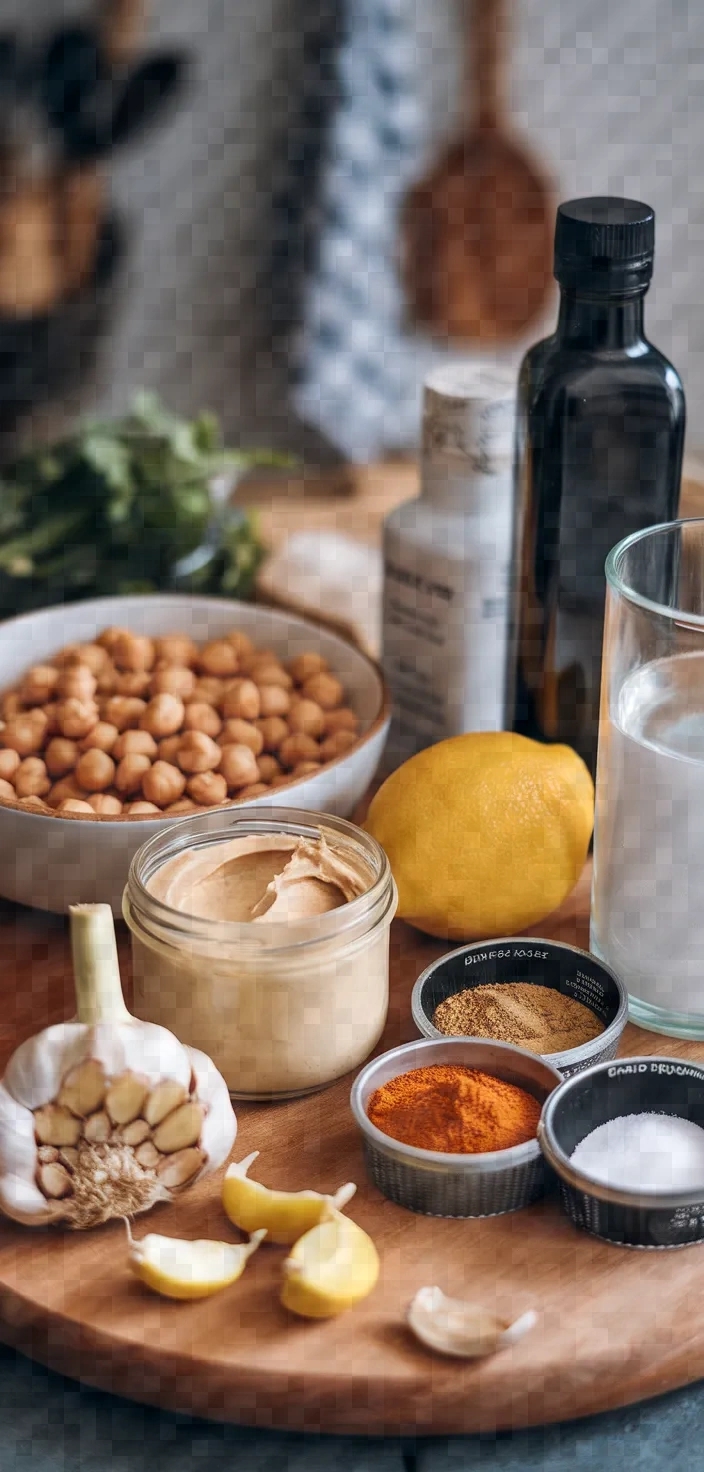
[365,732,594,941]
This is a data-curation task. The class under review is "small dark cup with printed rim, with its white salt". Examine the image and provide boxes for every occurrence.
[538,1058,704,1248]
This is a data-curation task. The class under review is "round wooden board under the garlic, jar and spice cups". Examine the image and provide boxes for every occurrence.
[0,873,704,1435]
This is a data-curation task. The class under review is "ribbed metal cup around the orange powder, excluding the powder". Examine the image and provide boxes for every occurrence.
[351,1038,561,1216]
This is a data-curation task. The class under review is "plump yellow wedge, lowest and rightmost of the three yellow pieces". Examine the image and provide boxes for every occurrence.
[281,1213,379,1319]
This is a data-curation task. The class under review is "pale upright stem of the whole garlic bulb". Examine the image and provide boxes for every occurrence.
[69,905,133,1026]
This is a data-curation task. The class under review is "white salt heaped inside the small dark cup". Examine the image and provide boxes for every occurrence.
[571,1114,704,1191]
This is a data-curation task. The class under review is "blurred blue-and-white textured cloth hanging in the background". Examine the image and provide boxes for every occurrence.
[293,0,423,461]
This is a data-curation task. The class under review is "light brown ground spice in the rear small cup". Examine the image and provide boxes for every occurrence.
[433,982,604,1052]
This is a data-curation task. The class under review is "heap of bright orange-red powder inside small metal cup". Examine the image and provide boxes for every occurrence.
[367,1063,541,1156]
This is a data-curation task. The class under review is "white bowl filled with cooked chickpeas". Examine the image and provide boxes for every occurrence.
[0,593,390,914]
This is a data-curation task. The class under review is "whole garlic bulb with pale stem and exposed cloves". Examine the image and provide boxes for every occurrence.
[0,905,237,1228]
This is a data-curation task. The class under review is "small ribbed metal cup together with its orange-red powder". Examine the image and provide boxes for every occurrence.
[351,1038,561,1217]
